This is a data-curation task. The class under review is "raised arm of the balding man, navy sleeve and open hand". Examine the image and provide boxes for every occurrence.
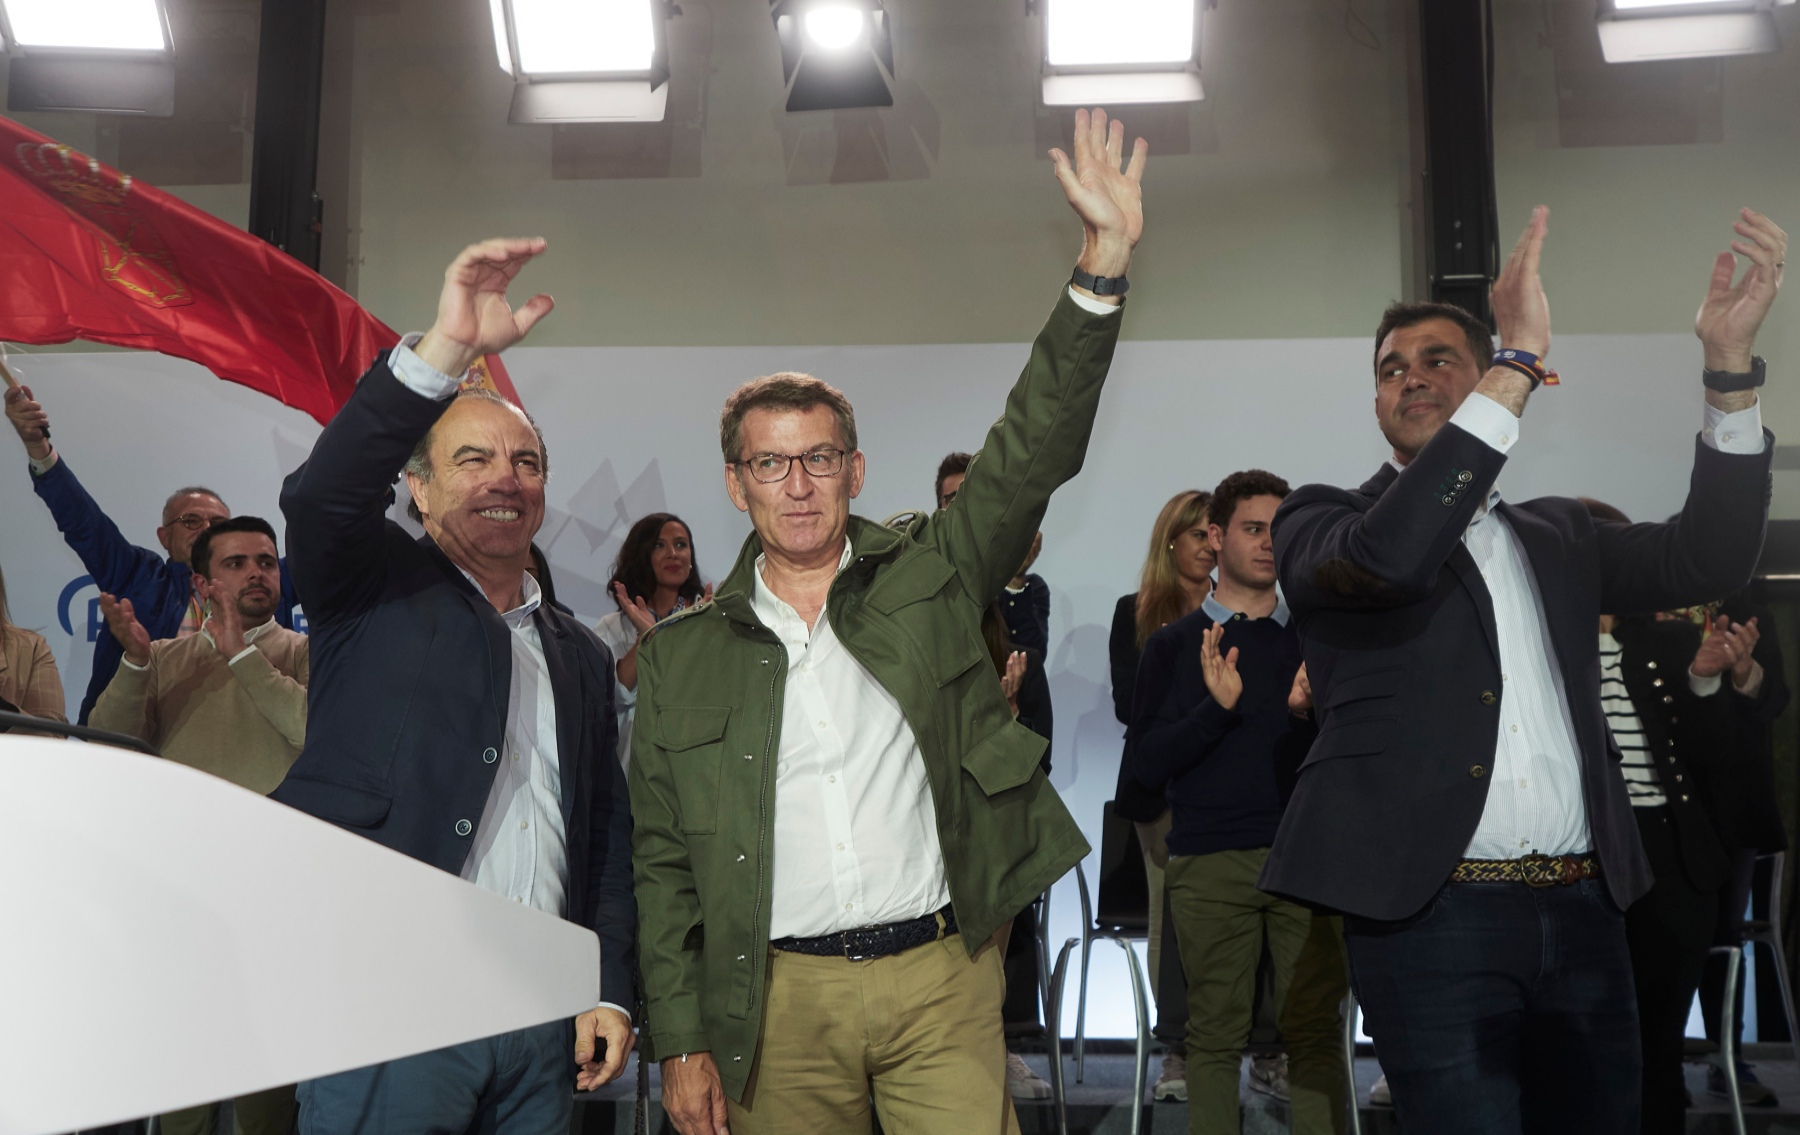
[281,237,554,624]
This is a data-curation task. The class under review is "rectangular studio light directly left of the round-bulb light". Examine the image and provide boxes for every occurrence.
[488,0,670,122]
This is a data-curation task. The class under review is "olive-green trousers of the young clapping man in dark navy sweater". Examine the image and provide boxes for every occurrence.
[1166,847,1350,1135]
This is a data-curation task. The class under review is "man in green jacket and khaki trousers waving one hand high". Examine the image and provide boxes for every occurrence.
[630,112,1147,1135]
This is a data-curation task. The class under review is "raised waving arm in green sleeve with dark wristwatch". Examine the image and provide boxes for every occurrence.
[931,110,1148,604]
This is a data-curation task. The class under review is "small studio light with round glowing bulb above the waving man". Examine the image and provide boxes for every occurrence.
[769,0,895,112]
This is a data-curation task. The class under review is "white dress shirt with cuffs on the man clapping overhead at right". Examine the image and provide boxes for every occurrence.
[1418,386,1762,860]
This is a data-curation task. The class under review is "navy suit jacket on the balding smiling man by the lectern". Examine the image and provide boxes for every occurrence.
[274,354,637,1007]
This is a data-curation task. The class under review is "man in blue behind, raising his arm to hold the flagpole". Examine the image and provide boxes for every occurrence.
[5,379,299,725]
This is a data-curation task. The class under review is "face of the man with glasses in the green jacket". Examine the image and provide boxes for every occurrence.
[725,405,862,565]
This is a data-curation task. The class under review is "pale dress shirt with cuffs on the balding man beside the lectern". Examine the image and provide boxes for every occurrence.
[389,335,630,1018]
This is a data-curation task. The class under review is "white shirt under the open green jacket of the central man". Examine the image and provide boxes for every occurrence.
[751,540,950,939]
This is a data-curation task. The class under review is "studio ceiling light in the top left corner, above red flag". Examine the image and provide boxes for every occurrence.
[0,0,175,117]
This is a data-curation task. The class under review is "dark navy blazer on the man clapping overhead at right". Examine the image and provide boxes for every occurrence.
[1260,425,1775,919]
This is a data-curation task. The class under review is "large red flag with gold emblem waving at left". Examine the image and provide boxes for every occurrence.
[0,117,518,423]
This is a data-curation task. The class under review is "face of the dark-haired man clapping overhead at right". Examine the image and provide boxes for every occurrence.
[1375,318,1483,464]
